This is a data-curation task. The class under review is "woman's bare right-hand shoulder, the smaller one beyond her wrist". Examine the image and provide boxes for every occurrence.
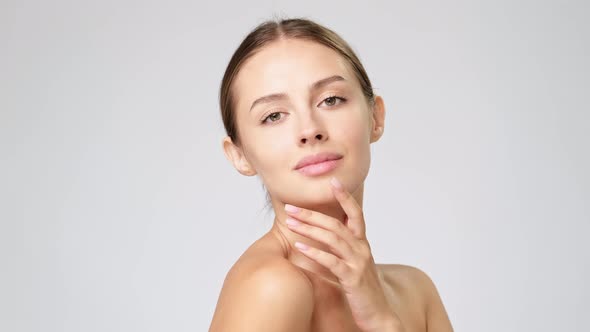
[378,264,453,331]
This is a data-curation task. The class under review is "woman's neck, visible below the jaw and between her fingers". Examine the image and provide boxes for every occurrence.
[269,184,364,283]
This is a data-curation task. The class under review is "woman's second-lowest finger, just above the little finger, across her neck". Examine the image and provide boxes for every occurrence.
[286,218,354,261]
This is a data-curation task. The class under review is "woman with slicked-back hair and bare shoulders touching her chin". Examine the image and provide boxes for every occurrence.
[210,19,452,332]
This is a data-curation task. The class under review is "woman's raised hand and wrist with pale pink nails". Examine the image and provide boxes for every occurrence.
[285,178,403,331]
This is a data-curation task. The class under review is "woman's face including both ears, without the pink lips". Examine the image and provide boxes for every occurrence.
[224,39,384,206]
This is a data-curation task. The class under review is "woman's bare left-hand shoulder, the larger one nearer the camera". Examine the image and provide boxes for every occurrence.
[209,239,313,332]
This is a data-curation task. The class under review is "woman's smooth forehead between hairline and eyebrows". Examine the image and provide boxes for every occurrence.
[234,39,355,109]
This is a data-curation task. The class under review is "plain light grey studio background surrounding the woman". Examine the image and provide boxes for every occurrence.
[0,0,590,332]
